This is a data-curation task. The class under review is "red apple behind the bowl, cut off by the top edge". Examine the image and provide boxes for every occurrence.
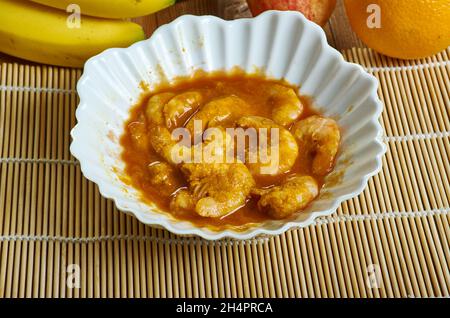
[247,0,336,26]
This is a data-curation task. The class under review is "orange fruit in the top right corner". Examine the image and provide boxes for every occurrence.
[344,0,450,59]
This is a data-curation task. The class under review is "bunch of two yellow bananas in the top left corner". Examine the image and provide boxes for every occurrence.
[0,0,175,67]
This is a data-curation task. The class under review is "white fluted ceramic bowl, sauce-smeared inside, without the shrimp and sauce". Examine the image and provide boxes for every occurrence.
[70,11,385,240]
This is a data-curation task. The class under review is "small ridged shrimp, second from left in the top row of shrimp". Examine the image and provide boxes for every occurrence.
[163,91,203,129]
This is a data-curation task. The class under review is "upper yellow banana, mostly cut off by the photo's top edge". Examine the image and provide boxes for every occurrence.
[27,0,175,19]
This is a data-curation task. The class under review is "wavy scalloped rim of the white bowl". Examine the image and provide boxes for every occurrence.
[70,10,387,240]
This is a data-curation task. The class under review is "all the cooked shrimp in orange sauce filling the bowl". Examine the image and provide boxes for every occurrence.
[120,71,341,229]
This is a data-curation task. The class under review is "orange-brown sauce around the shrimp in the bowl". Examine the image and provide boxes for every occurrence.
[120,72,323,229]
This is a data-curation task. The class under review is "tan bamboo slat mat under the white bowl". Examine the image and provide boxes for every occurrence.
[0,49,450,297]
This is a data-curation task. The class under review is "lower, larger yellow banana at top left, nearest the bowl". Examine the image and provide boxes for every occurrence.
[0,0,145,67]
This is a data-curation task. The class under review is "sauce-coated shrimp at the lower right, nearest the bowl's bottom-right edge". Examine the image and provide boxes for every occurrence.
[252,176,319,219]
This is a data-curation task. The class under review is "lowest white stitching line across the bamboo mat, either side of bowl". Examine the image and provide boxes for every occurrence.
[0,207,450,246]
